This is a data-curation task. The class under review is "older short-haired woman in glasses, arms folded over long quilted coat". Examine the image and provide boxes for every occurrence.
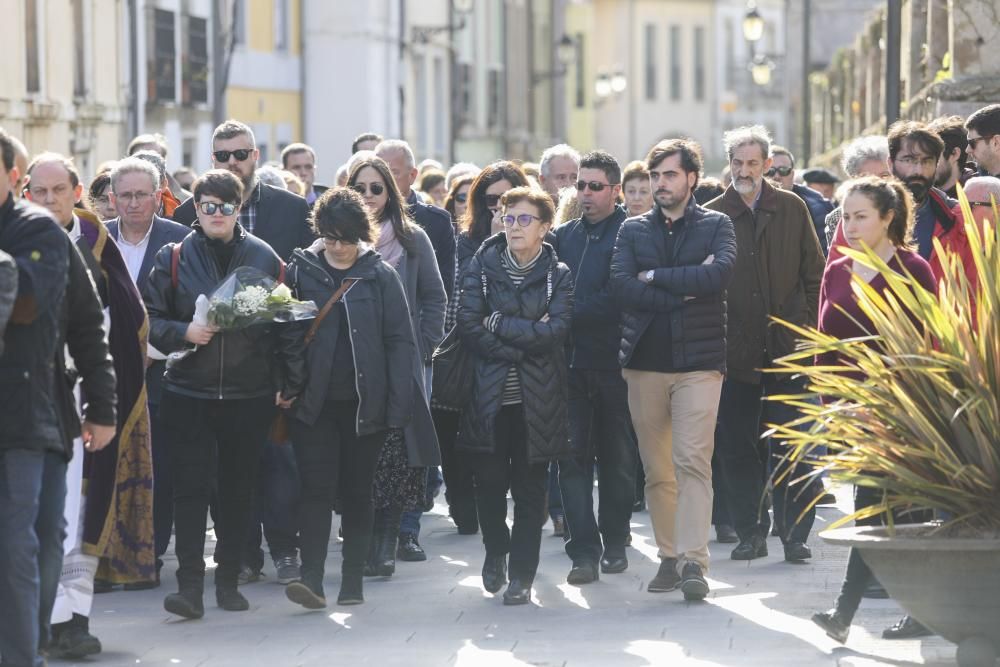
[456,187,573,605]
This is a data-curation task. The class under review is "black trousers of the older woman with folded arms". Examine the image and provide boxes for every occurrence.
[470,404,549,584]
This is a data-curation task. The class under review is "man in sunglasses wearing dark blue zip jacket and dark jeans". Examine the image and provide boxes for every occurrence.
[553,151,636,585]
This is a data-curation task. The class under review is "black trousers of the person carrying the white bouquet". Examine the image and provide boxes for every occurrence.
[160,389,274,590]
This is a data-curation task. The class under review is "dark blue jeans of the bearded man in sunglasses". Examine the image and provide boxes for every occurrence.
[550,368,638,565]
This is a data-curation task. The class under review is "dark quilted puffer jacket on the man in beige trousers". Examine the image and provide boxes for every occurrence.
[611,197,736,373]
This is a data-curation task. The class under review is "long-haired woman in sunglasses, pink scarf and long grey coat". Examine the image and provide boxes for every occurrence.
[347,156,447,577]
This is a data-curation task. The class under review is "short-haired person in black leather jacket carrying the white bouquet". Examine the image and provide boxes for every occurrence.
[143,169,305,618]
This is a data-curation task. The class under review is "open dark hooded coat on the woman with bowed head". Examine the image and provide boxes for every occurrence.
[288,241,416,435]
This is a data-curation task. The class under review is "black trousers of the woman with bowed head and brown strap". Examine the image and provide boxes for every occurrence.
[290,401,386,588]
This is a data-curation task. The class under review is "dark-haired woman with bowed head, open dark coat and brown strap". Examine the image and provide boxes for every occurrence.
[285,187,417,609]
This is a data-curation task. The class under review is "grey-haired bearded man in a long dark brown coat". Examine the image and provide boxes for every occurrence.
[706,126,824,561]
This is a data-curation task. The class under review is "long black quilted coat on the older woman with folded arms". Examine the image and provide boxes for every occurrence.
[456,232,573,463]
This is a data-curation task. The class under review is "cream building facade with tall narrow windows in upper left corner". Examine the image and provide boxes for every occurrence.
[0,0,126,178]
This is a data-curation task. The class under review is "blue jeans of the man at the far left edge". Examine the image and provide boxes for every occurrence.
[0,449,66,667]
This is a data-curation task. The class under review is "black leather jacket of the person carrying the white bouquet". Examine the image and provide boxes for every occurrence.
[142,224,305,399]
